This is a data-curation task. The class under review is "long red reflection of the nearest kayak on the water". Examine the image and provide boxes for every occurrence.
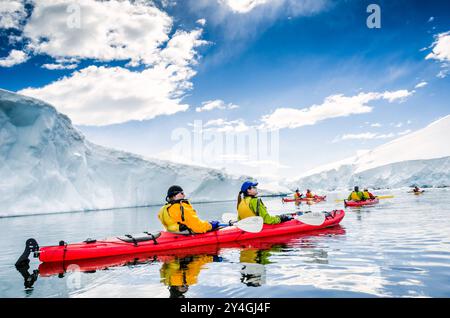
[39,225,345,277]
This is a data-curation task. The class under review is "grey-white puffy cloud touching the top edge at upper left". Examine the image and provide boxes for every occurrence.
[23,0,172,66]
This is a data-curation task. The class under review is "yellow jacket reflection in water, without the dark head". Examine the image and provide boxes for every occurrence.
[159,255,213,286]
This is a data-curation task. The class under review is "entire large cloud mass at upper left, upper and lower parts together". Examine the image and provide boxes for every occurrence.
[14,0,207,125]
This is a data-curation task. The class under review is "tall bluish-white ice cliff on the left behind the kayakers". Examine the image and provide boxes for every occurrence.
[0,90,253,216]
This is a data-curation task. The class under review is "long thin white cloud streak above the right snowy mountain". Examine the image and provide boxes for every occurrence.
[261,90,414,129]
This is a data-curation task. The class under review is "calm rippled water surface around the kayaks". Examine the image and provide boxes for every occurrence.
[0,189,450,297]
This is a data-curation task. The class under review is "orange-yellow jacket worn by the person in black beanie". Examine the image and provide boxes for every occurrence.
[158,200,212,233]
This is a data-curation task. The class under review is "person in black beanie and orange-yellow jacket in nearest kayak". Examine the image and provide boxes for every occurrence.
[158,185,219,233]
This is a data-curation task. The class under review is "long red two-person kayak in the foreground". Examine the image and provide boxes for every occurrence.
[35,210,345,263]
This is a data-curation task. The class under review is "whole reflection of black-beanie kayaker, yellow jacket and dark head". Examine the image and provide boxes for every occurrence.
[160,255,222,298]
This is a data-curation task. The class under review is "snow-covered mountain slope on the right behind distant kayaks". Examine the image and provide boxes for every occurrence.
[290,115,450,190]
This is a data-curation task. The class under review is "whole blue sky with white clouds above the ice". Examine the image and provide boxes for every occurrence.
[0,0,450,177]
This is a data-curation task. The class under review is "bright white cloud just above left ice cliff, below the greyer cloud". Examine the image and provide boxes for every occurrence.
[19,30,206,125]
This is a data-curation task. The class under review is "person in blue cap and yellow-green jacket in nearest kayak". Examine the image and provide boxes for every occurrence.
[237,181,293,224]
